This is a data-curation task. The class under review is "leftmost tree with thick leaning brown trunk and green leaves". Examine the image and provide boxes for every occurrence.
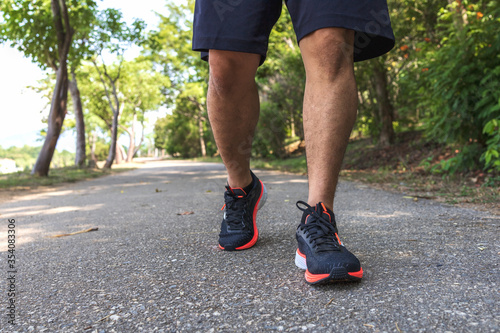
[0,0,96,176]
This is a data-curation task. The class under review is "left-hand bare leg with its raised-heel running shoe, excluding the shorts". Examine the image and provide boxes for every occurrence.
[207,50,267,251]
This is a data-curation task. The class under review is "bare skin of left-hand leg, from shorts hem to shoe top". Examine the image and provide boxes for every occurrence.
[207,50,261,188]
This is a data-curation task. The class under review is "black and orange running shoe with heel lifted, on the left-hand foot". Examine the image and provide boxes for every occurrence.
[219,172,267,251]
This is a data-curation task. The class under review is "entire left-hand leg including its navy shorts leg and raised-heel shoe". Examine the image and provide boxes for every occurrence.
[193,0,282,251]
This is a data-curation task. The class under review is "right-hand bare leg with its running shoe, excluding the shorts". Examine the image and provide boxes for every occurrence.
[295,28,363,284]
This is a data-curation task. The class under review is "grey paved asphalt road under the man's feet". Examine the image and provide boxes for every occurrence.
[0,162,500,332]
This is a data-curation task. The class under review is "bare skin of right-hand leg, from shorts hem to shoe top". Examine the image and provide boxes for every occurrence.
[299,28,358,209]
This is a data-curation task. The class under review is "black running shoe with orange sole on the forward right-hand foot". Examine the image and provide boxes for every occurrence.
[295,201,363,284]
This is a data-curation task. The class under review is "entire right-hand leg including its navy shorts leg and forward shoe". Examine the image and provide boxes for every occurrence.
[287,0,394,284]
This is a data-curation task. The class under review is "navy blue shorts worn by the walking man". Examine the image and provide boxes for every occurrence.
[193,0,394,63]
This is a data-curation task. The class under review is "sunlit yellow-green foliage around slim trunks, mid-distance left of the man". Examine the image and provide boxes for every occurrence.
[78,59,170,163]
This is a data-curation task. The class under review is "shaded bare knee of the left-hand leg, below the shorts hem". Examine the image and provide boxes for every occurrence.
[208,50,260,95]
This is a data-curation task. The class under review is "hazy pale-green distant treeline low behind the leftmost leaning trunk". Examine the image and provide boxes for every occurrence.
[0,145,75,170]
